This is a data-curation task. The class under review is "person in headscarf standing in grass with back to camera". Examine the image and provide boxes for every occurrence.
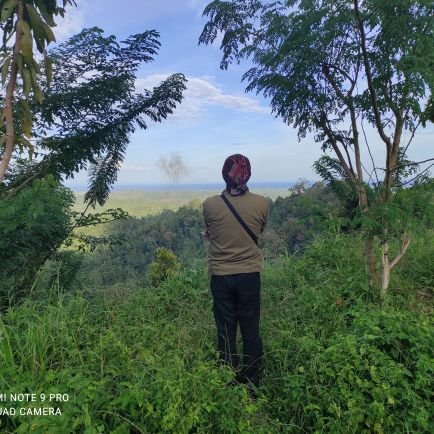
[203,154,269,386]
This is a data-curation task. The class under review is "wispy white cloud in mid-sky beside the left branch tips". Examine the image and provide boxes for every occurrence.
[136,74,269,121]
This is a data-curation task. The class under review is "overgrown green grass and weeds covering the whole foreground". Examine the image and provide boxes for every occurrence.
[0,233,434,433]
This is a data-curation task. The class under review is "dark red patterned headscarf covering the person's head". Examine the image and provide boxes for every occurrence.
[222,154,251,196]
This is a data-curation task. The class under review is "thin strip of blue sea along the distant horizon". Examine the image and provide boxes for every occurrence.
[69,181,295,192]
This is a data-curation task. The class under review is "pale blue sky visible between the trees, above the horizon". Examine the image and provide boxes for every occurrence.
[55,0,434,185]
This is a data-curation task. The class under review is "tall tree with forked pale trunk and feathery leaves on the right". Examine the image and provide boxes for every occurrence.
[199,0,434,296]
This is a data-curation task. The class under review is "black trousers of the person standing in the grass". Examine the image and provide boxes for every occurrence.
[211,273,262,384]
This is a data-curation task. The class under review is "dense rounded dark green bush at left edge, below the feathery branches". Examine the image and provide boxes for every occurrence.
[0,177,74,307]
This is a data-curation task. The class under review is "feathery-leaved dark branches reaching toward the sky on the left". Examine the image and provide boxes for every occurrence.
[3,28,186,205]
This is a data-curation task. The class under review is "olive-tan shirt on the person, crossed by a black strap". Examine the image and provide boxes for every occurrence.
[203,191,270,275]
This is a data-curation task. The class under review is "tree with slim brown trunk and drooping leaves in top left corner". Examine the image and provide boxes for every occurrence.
[0,0,75,182]
